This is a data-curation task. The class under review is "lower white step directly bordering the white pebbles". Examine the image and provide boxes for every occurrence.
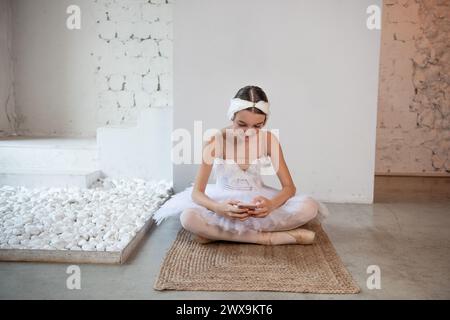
[0,169,102,188]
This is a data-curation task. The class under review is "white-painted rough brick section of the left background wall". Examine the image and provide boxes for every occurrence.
[93,0,173,126]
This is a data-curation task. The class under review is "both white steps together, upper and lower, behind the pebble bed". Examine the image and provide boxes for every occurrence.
[0,137,102,188]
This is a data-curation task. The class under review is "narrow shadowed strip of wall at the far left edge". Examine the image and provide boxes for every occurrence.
[0,0,16,136]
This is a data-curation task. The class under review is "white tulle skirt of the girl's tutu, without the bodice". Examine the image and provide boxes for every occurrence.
[153,184,329,233]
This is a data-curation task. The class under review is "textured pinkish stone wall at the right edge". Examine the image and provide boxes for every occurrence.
[376,0,450,176]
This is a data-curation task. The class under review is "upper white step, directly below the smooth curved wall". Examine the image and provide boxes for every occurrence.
[0,137,98,172]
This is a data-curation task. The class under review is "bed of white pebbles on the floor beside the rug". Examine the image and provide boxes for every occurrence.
[0,178,172,251]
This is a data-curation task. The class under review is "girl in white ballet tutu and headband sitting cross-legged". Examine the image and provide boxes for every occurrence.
[153,86,329,245]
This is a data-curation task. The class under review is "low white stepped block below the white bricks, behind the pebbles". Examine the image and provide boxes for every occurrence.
[97,108,173,181]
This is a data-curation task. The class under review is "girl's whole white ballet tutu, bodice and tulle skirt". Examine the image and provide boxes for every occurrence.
[153,158,329,233]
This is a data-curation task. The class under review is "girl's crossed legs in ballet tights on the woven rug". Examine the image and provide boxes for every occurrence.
[180,199,318,245]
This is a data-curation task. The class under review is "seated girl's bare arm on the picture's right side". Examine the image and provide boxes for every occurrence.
[267,131,297,208]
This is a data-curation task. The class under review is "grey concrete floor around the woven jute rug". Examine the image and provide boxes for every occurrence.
[0,202,450,300]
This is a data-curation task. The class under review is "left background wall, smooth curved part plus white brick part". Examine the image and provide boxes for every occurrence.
[11,0,172,137]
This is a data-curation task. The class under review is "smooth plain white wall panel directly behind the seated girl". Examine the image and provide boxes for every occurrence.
[174,0,381,202]
